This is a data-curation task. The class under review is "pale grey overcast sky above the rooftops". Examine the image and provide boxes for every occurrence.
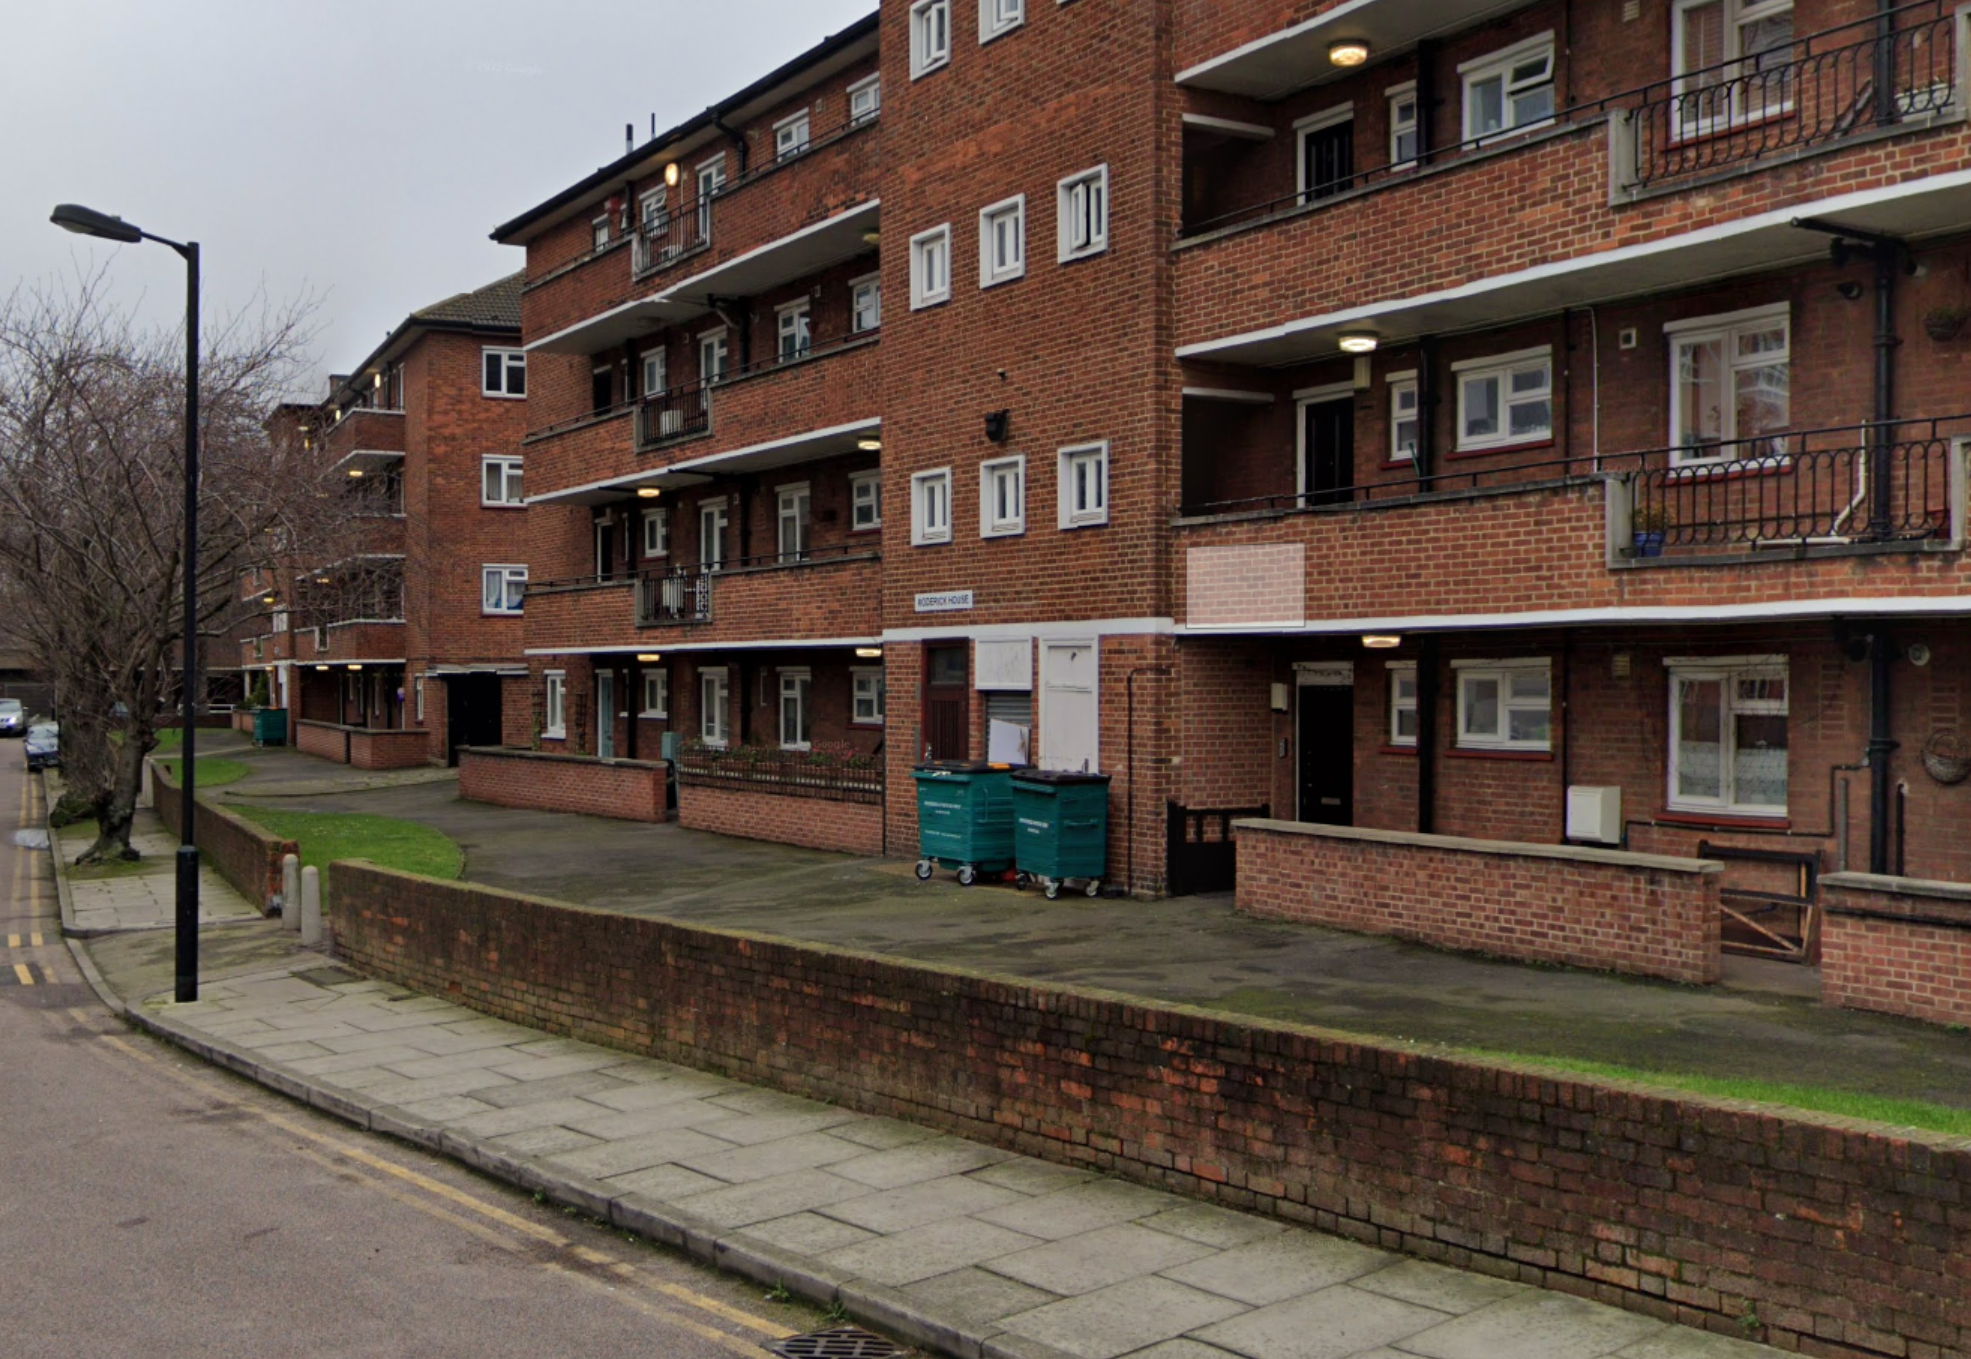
[0,0,875,392]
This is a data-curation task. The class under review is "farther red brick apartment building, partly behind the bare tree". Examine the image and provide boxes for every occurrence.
[240,274,552,769]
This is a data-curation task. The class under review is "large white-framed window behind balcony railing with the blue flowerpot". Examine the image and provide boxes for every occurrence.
[1664,304,1792,464]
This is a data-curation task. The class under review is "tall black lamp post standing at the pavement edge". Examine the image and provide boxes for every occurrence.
[49,203,201,1004]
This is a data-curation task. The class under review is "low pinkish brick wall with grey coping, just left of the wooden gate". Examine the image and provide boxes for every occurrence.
[1236,821,1725,982]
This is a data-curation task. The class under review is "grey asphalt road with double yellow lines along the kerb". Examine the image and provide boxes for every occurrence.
[0,742,824,1359]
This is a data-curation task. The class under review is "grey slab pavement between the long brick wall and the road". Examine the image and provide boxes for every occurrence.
[112,957,1776,1359]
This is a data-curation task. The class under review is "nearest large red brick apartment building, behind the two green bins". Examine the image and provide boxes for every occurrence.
[489,0,1971,1010]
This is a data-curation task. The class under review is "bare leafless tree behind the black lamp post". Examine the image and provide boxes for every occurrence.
[0,274,347,862]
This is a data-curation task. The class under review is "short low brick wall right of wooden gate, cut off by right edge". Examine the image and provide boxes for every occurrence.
[1821,874,1971,1025]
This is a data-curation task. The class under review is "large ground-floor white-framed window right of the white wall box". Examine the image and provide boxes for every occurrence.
[1665,657,1788,817]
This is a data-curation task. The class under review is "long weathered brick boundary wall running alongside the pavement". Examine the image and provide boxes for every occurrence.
[329,862,1971,1359]
